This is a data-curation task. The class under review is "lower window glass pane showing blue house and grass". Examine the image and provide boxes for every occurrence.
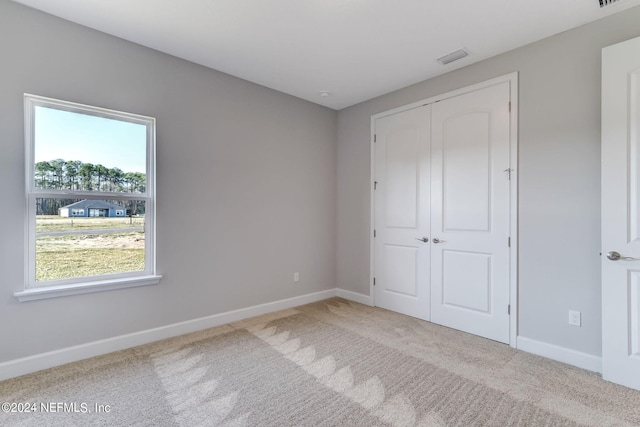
[35,198,145,282]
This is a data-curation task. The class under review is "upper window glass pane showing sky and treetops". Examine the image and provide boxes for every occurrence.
[34,106,147,193]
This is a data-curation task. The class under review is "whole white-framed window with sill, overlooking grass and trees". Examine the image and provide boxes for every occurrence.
[15,94,160,301]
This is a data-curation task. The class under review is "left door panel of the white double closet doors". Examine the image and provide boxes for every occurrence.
[374,106,430,320]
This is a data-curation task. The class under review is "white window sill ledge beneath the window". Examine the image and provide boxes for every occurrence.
[13,276,162,302]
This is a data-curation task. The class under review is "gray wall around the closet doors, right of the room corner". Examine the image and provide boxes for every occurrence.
[337,7,640,356]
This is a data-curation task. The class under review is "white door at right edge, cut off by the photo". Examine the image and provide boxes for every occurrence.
[602,38,640,390]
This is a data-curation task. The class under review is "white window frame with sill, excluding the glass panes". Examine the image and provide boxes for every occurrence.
[14,94,161,302]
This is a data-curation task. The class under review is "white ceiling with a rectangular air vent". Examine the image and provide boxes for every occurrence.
[14,0,640,109]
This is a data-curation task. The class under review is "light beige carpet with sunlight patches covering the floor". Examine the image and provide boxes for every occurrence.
[0,298,640,426]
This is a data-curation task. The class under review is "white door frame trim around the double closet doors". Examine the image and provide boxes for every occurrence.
[369,72,518,348]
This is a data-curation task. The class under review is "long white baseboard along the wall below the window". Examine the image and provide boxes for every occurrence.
[0,289,338,381]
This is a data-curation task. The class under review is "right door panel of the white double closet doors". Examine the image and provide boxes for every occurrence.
[431,82,510,343]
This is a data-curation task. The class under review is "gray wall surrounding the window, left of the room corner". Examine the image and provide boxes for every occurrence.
[0,0,337,362]
